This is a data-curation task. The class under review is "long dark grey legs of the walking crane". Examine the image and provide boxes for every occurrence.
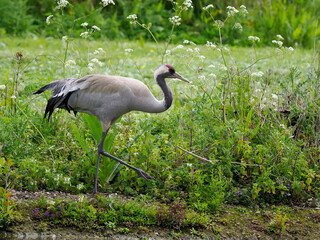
[91,129,155,196]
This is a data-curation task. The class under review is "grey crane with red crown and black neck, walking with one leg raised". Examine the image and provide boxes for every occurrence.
[34,64,189,196]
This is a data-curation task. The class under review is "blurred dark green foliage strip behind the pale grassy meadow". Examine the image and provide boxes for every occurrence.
[0,0,320,48]
